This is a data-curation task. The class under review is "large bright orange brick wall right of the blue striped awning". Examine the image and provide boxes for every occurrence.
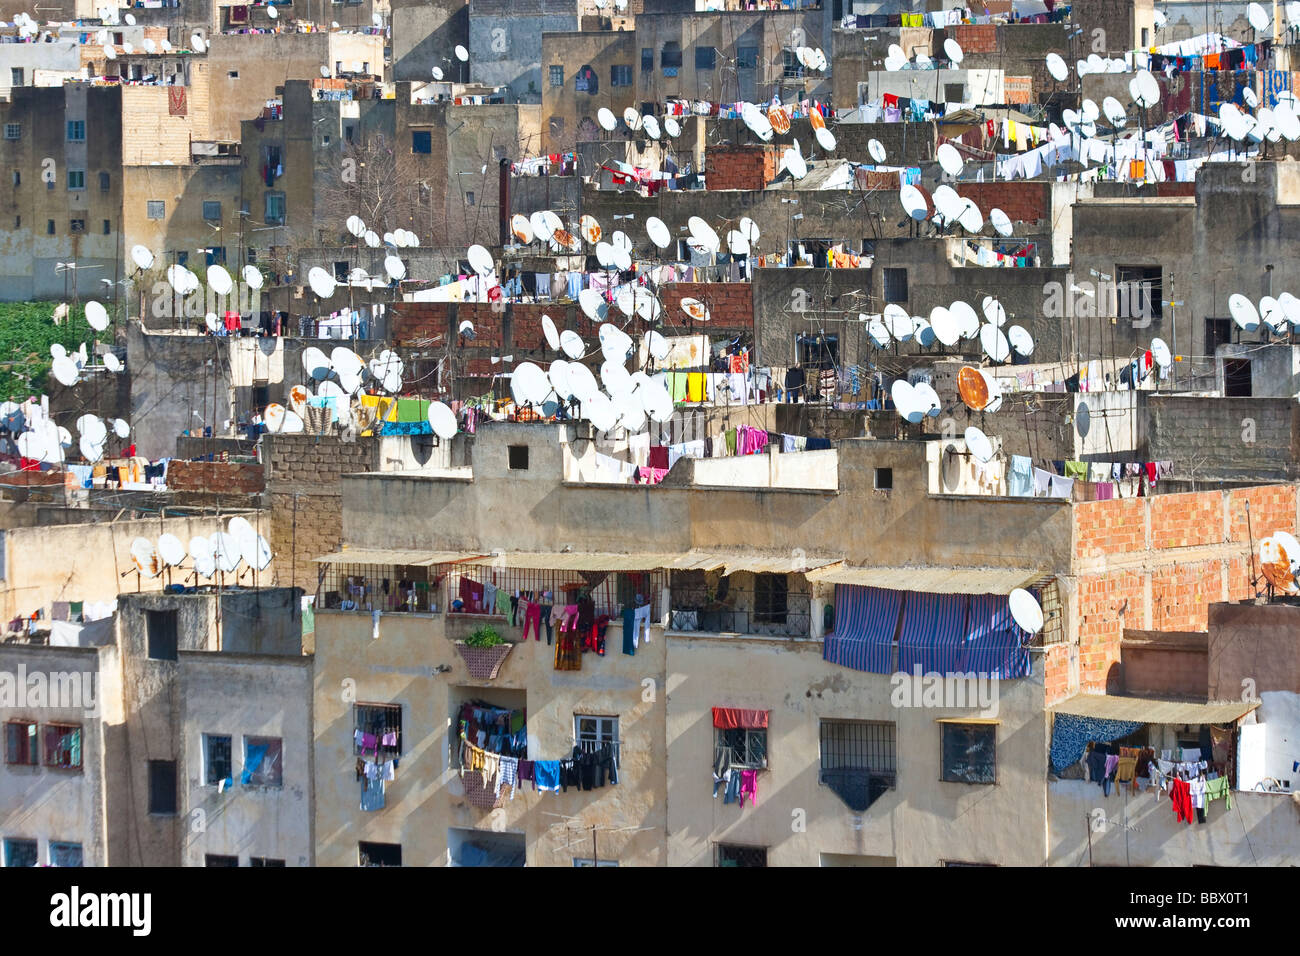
[1066,484,1297,702]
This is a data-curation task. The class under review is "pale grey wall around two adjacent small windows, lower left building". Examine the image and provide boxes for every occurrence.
[178,650,313,866]
